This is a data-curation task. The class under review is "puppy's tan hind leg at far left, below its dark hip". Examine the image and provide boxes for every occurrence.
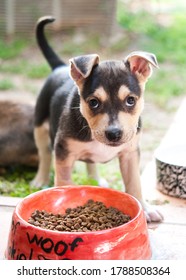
[31,122,52,187]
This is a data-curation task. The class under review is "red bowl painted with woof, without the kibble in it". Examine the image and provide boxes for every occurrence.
[5,186,151,260]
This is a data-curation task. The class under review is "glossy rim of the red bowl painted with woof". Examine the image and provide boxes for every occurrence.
[14,185,145,236]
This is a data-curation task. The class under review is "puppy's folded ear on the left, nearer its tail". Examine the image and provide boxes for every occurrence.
[69,54,99,84]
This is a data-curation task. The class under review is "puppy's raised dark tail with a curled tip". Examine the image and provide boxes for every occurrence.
[36,16,66,70]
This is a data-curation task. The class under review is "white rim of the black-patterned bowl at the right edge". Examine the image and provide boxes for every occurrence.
[154,145,186,168]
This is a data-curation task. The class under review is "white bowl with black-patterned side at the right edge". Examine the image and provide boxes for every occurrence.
[155,146,186,198]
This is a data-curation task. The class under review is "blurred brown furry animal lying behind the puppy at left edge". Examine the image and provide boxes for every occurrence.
[0,99,39,172]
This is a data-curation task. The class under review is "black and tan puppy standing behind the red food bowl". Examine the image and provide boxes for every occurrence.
[33,17,162,221]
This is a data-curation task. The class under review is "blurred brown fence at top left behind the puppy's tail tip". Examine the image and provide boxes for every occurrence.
[0,0,117,37]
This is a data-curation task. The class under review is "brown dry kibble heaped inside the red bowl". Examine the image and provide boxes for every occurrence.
[28,200,131,232]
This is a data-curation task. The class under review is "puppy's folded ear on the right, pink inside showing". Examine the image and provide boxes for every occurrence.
[125,51,158,82]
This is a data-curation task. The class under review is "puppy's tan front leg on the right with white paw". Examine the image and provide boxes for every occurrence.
[119,149,163,222]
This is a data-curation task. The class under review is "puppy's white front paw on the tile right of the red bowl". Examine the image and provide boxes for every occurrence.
[142,202,164,223]
